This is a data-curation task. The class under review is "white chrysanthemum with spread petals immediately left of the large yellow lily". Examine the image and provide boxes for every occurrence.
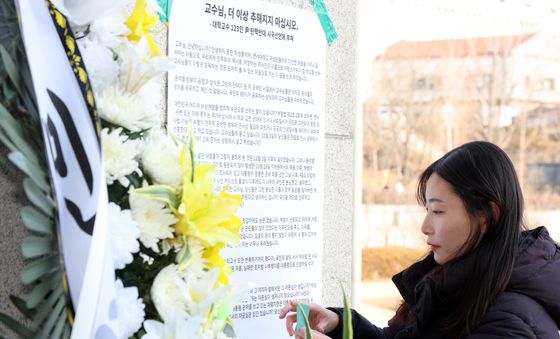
[128,195,177,252]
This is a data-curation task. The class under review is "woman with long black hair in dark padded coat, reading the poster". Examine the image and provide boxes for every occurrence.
[280,141,560,339]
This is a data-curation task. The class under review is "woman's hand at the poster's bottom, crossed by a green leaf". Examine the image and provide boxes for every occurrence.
[280,300,339,339]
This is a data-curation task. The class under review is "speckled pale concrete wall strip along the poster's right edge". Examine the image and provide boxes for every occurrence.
[312,0,361,305]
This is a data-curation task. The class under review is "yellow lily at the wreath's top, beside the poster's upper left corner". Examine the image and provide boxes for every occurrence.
[125,0,162,56]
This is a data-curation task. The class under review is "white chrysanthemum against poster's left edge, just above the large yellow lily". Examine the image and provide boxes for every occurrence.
[142,129,181,188]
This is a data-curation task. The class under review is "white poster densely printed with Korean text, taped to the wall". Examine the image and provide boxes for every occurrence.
[168,0,326,339]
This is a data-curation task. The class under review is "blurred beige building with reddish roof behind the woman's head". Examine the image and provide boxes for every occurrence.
[364,33,560,202]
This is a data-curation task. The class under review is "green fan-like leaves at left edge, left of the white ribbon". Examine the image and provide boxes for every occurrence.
[0,0,70,338]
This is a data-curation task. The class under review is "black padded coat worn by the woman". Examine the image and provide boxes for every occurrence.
[327,227,560,339]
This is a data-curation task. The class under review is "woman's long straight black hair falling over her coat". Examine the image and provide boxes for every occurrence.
[395,141,525,337]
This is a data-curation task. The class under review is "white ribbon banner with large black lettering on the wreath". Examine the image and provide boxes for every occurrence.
[18,0,117,338]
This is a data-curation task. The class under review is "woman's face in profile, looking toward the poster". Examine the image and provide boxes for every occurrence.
[422,173,474,265]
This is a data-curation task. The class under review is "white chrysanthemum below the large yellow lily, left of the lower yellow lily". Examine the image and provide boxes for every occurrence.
[150,264,187,321]
